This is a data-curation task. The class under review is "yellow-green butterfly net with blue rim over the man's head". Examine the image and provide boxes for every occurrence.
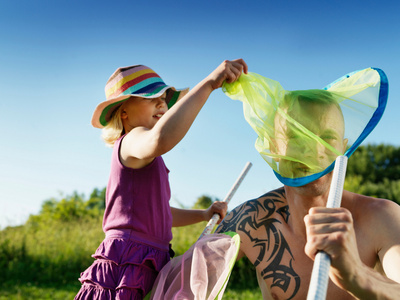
[223,68,388,186]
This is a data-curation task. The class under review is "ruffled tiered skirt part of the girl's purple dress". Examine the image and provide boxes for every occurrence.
[75,230,170,300]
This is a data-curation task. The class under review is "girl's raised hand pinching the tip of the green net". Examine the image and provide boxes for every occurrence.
[206,58,248,90]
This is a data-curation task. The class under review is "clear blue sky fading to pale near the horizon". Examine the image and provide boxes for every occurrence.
[0,0,400,228]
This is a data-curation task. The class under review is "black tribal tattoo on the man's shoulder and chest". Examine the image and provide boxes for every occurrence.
[218,188,300,299]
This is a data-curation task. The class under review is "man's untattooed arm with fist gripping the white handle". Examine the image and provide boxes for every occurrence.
[305,199,400,299]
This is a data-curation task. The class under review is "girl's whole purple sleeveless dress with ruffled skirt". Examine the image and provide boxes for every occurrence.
[75,137,172,299]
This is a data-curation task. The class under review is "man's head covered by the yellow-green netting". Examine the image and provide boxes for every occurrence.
[271,90,347,178]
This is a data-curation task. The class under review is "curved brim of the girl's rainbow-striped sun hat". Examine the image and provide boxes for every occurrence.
[91,86,189,129]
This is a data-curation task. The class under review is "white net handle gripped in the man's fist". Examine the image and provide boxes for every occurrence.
[307,156,347,300]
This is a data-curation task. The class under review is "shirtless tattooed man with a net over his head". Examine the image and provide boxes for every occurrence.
[217,92,400,300]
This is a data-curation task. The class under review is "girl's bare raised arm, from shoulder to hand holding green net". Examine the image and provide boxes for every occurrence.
[121,59,247,167]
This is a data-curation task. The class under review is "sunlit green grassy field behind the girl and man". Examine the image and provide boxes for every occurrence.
[0,217,261,300]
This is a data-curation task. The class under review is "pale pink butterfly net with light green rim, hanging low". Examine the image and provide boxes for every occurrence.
[150,232,240,300]
